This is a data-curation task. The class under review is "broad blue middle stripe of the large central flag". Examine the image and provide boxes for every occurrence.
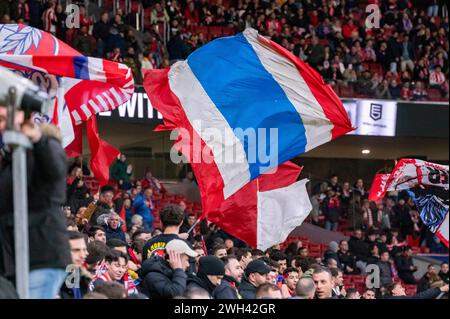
[188,34,307,179]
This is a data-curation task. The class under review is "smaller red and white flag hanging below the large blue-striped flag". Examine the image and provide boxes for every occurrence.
[204,162,312,250]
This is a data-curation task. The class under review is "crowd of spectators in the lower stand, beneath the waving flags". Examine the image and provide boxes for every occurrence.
[45,154,448,299]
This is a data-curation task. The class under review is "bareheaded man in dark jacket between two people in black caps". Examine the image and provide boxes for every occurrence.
[213,255,244,299]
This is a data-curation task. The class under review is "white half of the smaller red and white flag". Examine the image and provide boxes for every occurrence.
[257,178,312,251]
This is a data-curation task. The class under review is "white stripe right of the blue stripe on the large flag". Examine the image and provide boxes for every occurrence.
[244,29,334,152]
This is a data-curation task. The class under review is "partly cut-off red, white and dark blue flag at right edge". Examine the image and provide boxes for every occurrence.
[369,159,449,247]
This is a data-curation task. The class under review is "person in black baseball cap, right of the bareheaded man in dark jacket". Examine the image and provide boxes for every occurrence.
[239,259,272,299]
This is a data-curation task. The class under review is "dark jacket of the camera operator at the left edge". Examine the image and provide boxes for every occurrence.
[0,135,71,277]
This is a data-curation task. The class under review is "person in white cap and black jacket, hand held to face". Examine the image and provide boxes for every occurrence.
[142,239,197,299]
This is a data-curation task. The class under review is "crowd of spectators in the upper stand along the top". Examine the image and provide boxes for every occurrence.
[0,0,449,101]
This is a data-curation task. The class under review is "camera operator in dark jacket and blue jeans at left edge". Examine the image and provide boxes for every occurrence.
[0,120,71,299]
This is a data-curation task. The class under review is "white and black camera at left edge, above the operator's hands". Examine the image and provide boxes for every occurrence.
[0,67,50,116]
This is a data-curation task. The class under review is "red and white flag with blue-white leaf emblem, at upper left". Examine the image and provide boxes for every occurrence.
[0,24,134,184]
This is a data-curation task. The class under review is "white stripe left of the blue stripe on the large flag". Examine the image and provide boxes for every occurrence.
[168,61,250,199]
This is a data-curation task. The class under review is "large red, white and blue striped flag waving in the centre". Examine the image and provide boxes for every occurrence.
[144,29,353,212]
